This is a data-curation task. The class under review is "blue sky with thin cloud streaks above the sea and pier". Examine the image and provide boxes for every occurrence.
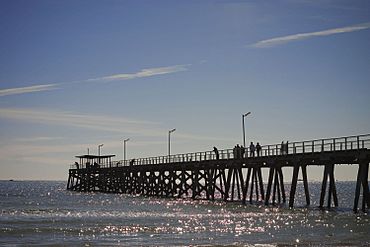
[0,0,370,180]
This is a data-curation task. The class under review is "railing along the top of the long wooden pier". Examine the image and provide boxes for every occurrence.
[71,134,370,168]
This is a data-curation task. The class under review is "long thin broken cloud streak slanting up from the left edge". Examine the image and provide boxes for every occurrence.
[0,64,190,97]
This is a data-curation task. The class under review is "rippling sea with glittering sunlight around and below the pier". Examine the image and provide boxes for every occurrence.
[0,181,370,246]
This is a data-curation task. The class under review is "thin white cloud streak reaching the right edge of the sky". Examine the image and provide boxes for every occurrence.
[252,22,370,48]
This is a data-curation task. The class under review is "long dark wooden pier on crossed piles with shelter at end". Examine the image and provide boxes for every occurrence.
[67,134,370,212]
